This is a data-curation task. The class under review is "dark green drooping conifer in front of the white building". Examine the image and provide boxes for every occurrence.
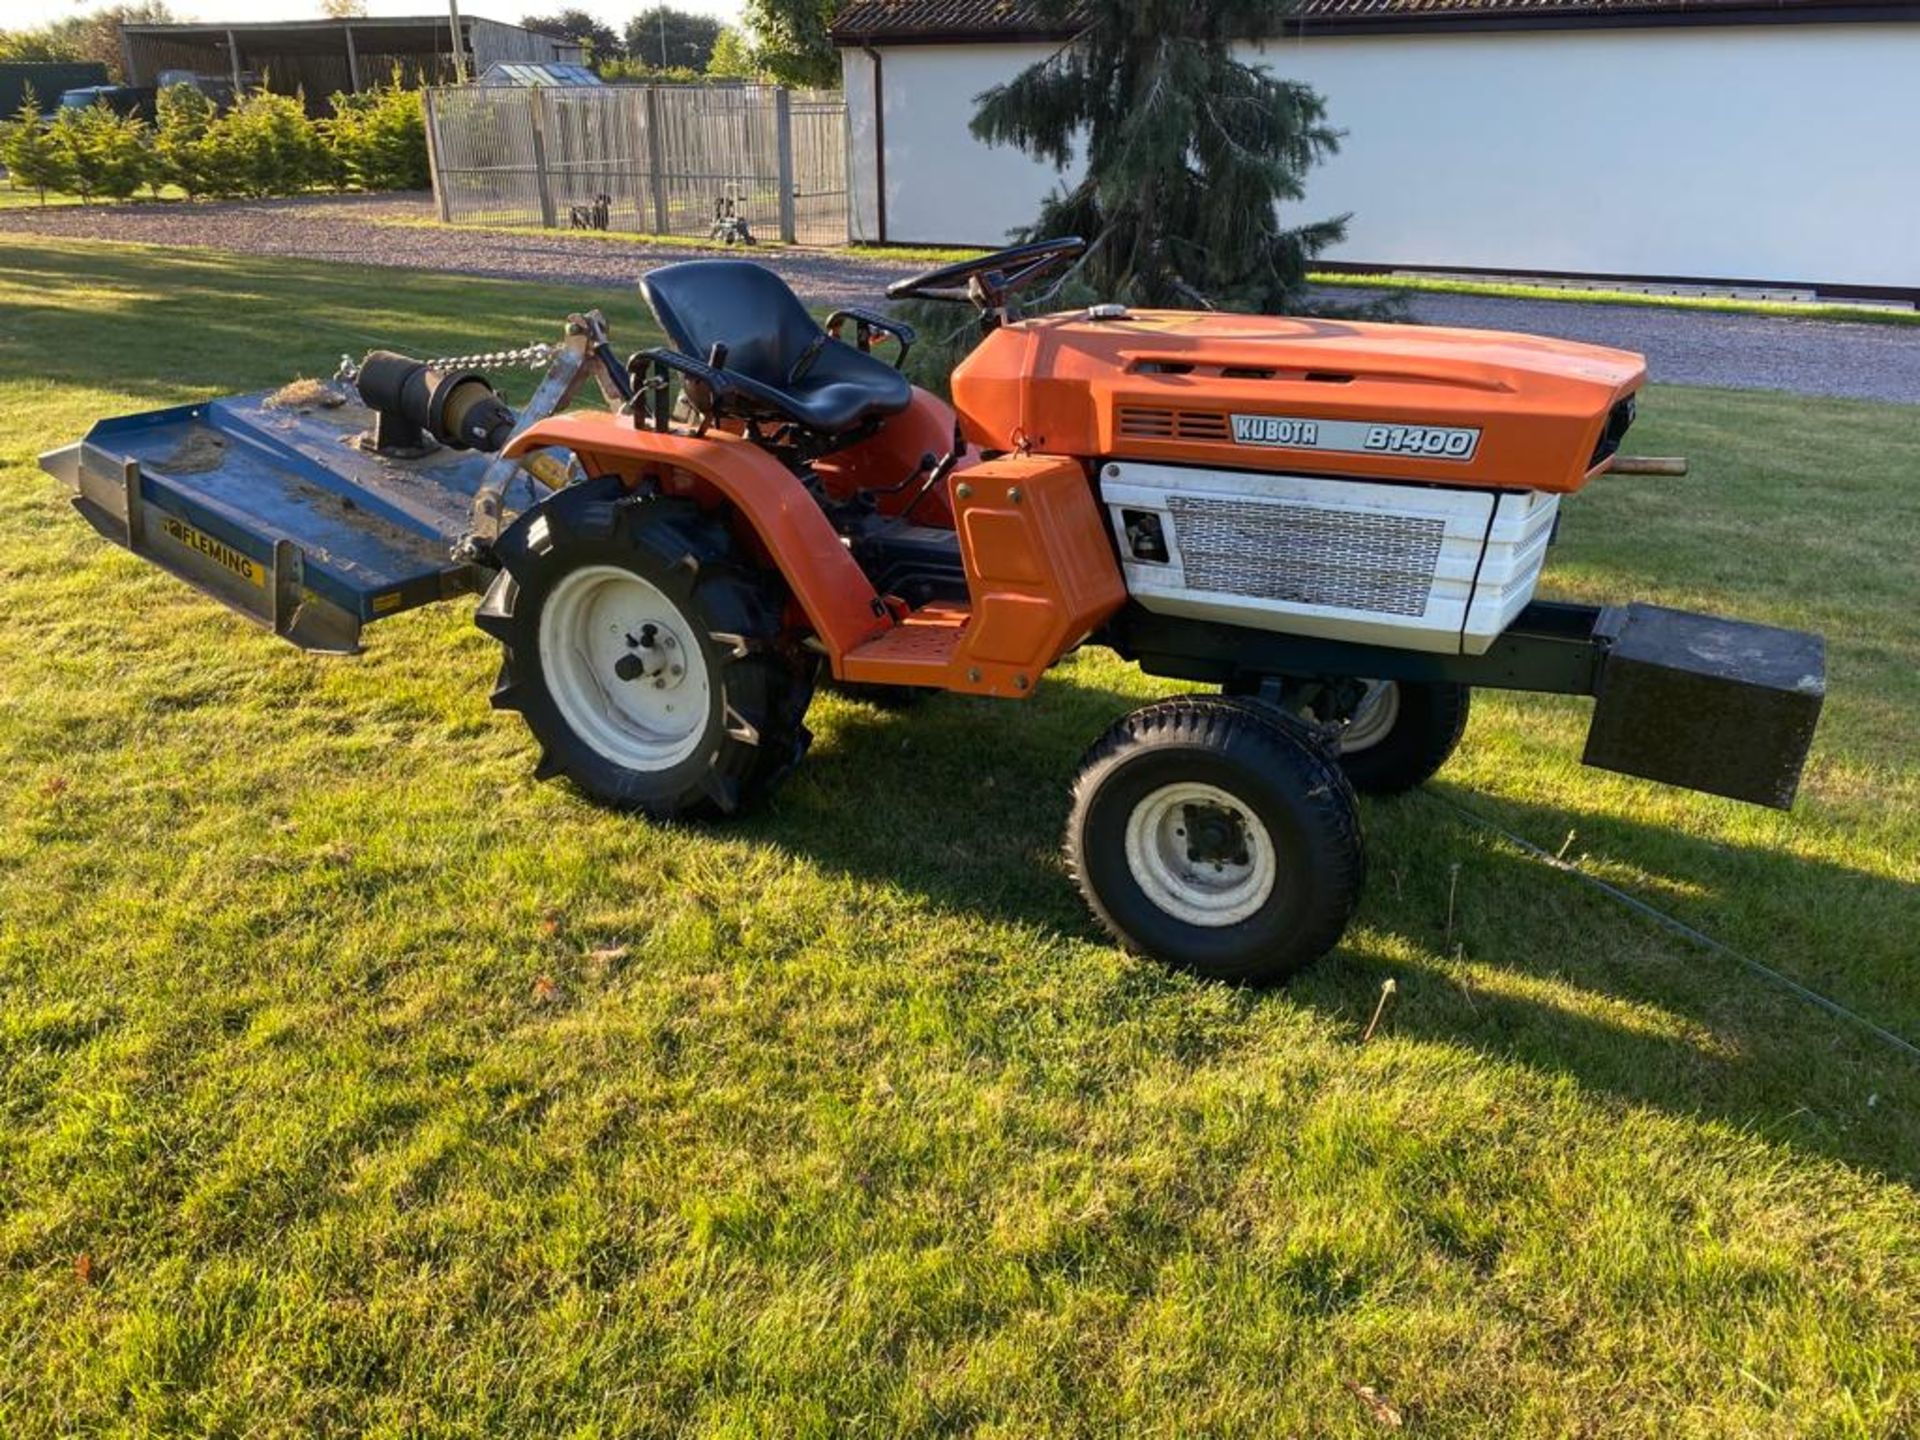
[973,0,1346,313]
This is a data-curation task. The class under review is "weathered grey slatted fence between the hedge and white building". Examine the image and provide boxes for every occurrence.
[426,84,849,246]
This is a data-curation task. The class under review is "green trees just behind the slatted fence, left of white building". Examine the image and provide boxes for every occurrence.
[520,0,839,86]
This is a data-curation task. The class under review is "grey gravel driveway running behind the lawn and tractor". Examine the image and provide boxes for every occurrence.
[0,196,1920,403]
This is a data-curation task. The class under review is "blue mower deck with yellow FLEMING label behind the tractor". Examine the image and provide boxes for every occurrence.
[40,388,488,653]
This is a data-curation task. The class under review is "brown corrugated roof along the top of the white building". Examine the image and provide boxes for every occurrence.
[831,0,1916,44]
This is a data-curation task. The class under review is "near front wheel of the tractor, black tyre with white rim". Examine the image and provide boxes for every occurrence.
[1066,695,1367,985]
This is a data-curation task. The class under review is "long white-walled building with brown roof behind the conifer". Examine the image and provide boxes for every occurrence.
[833,0,1920,298]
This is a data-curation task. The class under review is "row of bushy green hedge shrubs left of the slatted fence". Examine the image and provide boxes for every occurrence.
[0,84,428,200]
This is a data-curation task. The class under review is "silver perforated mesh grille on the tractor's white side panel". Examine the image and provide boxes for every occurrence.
[1165,495,1446,616]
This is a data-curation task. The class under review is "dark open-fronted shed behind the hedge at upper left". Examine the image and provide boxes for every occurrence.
[121,12,582,113]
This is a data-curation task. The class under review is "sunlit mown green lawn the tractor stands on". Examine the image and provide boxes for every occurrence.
[0,238,1920,1436]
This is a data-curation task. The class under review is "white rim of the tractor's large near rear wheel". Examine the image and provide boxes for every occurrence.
[540,564,712,770]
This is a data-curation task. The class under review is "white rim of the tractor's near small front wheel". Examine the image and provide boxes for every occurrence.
[1127,783,1279,929]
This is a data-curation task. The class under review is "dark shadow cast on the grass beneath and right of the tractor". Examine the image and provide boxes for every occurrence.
[741,680,1920,1181]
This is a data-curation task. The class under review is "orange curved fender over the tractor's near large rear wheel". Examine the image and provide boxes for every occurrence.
[501,413,893,674]
